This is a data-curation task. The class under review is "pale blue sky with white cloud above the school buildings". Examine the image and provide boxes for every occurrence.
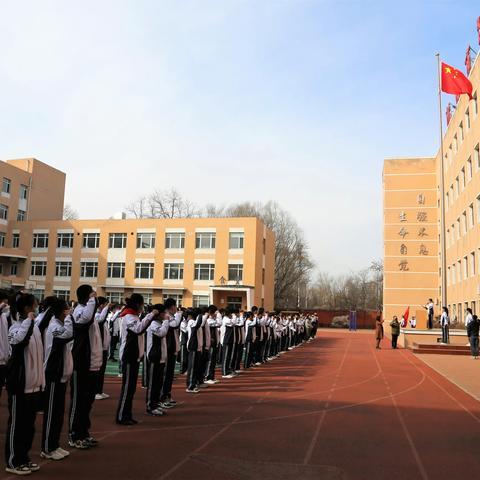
[0,0,480,273]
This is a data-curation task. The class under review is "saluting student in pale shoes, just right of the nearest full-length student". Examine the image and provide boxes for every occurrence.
[40,298,73,460]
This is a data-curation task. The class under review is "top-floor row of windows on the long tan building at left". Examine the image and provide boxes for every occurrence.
[25,232,244,249]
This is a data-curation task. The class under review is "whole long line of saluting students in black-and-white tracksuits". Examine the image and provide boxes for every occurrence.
[0,285,316,475]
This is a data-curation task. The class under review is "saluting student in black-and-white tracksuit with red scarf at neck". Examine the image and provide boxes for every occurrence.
[116,293,158,425]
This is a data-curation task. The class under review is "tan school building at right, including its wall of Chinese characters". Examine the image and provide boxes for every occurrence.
[383,54,480,326]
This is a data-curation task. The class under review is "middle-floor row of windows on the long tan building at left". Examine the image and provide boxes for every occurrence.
[29,260,243,281]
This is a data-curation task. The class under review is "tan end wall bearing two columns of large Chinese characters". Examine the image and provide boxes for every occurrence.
[383,158,439,328]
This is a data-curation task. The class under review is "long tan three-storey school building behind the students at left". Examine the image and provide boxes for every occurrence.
[0,158,275,309]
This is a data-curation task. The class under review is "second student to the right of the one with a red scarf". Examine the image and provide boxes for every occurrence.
[160,298,182,408]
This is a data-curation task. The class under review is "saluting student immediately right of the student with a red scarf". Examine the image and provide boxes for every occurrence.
[145,304,170,417]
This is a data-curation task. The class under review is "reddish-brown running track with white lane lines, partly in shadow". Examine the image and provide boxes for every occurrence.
[0,330,480,480]
